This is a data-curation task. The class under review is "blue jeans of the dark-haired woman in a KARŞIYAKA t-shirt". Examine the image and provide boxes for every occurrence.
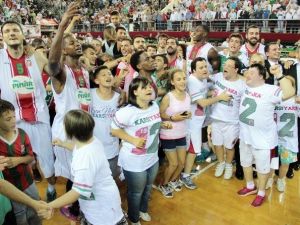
[123,162,158,223]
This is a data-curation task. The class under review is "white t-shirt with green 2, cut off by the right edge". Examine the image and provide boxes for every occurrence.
[275,98,300,152]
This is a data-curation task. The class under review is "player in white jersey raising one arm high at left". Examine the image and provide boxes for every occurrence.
[49,2,91,220]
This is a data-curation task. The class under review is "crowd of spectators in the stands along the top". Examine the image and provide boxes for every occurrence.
[0,0,300,32]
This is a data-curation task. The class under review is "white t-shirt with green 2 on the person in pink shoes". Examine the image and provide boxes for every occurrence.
[239,84,282,149]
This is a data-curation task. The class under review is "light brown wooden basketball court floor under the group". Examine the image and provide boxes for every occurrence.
[38,162,300,225]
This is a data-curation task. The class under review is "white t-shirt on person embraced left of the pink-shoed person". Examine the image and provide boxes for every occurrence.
[210,73,246,124]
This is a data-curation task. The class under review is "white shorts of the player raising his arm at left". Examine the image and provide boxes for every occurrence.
[52,118,72,180]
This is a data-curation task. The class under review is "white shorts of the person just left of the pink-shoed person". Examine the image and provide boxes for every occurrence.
[211,120,240,149]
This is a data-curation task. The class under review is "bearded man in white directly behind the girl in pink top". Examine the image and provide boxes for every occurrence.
[166,37,186,72]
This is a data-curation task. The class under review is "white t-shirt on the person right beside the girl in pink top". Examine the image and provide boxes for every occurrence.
[187,74,208,119]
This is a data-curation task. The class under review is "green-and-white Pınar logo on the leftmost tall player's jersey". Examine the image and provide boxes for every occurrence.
[10,76,35,94]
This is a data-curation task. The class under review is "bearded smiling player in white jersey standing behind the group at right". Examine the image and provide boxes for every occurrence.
[240,25,265,59]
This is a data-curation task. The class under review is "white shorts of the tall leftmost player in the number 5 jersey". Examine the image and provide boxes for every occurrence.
[17,120,54,178]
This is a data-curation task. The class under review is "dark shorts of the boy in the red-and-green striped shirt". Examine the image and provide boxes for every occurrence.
[12,183,42,225]
